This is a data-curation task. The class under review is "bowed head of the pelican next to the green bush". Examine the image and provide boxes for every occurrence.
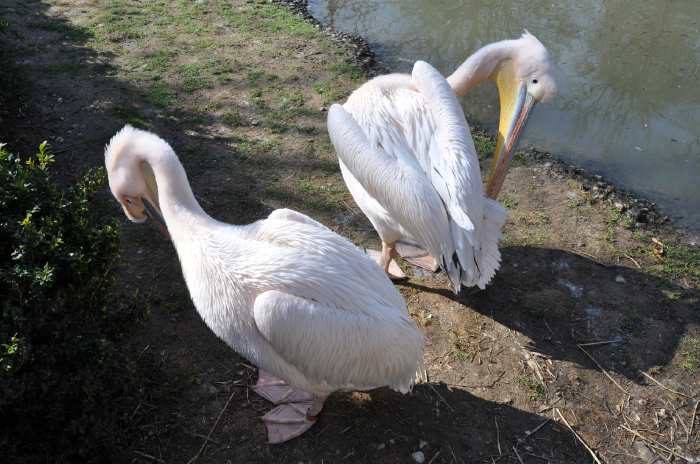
[105,125,171,236]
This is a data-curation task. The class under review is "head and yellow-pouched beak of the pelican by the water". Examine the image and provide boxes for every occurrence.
[486,31,557,198]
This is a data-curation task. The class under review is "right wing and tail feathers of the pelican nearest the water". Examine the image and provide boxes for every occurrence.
[405,61,505,288]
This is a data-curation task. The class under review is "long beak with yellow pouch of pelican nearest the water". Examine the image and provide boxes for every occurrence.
[486,65,537,199]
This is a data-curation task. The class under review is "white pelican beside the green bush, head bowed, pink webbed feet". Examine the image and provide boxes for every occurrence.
[105,126,424,443]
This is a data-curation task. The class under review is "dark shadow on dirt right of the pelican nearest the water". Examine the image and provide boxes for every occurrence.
[402,246,700,382]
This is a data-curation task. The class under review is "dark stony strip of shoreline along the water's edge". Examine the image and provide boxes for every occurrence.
[273,0,700,246]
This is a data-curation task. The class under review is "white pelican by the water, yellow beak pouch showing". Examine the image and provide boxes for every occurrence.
[328,31,556,293]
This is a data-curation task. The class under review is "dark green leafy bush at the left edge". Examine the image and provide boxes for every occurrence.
[0,142,139,462]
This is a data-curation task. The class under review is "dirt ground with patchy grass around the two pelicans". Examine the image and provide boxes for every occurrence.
[0,0,700,464]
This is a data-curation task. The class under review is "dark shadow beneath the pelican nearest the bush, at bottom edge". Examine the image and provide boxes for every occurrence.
[266,383,590,464]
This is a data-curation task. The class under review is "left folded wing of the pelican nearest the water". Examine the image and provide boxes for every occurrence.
[328,105,460,288]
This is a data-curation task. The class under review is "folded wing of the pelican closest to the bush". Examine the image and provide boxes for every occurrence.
[253,290,423,392]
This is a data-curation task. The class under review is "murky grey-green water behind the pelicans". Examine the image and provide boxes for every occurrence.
[309,0,700,229]
